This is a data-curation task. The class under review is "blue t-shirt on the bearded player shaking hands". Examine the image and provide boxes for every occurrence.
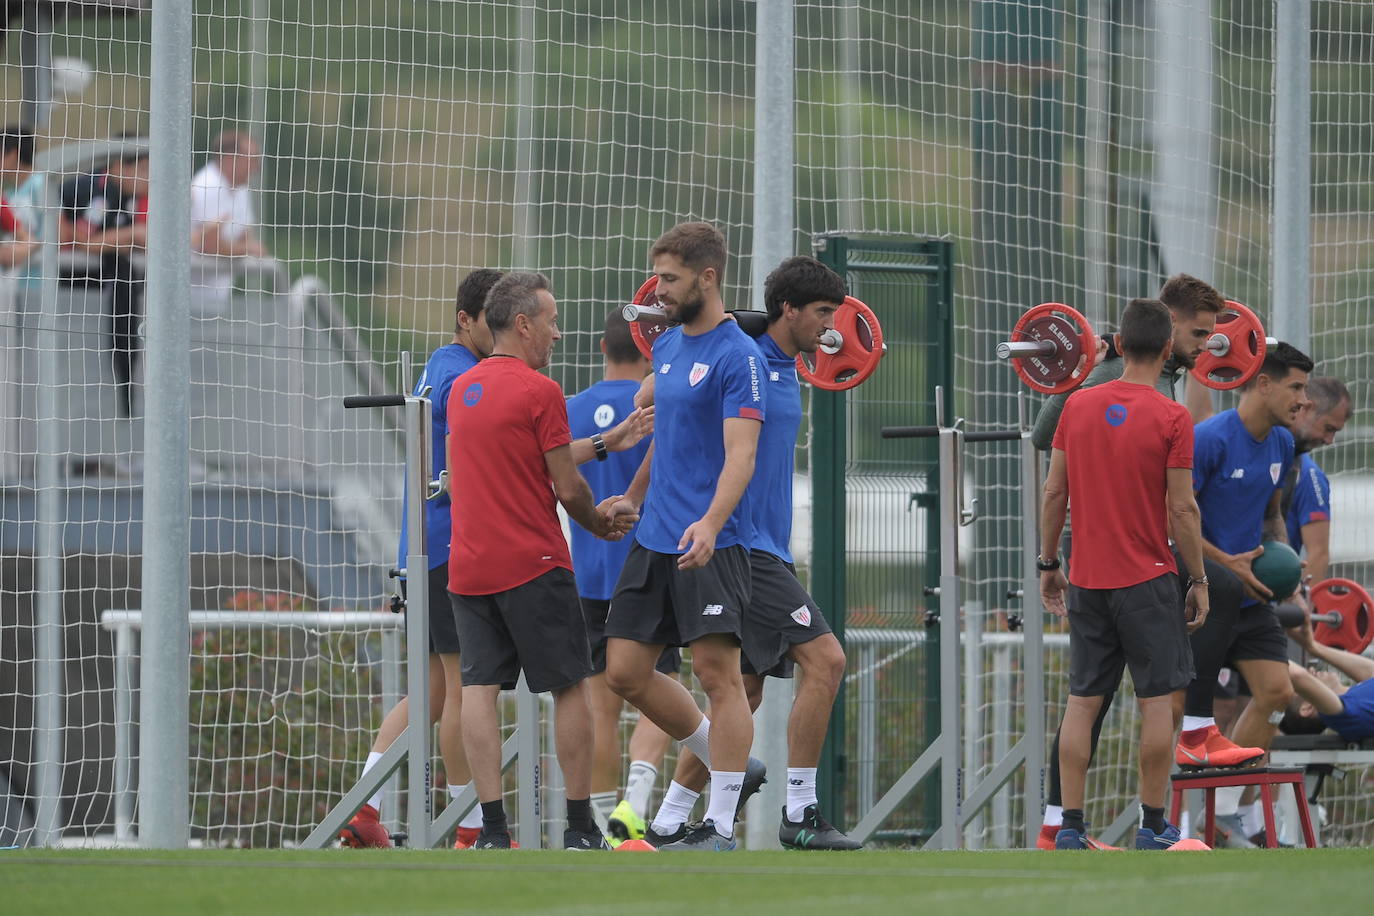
[635,320,767,553]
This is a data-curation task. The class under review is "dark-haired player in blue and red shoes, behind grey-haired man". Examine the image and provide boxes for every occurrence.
[339,269,502,849]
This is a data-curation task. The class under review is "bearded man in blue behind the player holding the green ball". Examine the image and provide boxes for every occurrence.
[1283,376,1351,582]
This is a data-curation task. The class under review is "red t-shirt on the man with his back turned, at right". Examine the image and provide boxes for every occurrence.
[1054,380,1193,588]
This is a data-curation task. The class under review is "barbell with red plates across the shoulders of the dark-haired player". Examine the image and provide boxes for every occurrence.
[621,275,888,391]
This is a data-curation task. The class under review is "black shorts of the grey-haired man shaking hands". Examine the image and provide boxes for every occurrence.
[449,567,592,694]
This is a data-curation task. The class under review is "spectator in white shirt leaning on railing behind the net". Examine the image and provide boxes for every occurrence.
[191,130,267,314]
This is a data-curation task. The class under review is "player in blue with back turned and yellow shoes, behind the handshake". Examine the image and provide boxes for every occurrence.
[567,306,680,846]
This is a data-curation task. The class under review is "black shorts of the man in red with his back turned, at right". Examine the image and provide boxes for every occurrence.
[1069,573,1193,699]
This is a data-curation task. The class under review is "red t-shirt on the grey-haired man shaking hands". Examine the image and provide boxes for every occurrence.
[448,356,573,595]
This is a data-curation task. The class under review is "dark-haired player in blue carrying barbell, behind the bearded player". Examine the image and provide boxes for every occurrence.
[649,257,861,850]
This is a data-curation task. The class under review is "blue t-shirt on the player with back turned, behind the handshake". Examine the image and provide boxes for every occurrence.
[567,379,650,602]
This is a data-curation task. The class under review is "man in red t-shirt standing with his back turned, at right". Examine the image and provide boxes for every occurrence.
[1036,299,1208,849]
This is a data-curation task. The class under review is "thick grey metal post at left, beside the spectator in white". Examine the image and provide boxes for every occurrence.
[139,0,194,849]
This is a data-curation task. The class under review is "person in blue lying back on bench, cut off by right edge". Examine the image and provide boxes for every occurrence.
[1285,609,1374,743]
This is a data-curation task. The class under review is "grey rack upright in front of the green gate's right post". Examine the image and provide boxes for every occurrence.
[940,426,963,849]
